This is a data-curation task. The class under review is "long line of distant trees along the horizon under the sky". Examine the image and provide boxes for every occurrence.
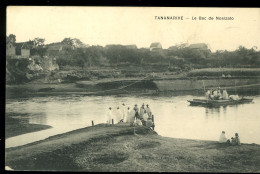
[6,34,260,70]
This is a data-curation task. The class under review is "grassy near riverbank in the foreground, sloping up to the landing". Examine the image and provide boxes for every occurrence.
[6,124,260,172]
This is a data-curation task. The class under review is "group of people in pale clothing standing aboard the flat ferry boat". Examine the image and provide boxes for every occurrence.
[205,87,229,100]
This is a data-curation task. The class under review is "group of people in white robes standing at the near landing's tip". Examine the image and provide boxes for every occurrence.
[106,103,154,127]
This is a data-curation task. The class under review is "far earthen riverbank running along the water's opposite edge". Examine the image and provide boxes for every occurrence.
[6,77,260,98]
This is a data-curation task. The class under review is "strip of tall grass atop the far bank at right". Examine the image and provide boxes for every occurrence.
[188,68,260,76]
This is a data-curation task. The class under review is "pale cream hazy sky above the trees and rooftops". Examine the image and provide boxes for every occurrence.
[6,6,260,51]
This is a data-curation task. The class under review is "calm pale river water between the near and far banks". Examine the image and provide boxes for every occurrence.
[6,95,260,148]
